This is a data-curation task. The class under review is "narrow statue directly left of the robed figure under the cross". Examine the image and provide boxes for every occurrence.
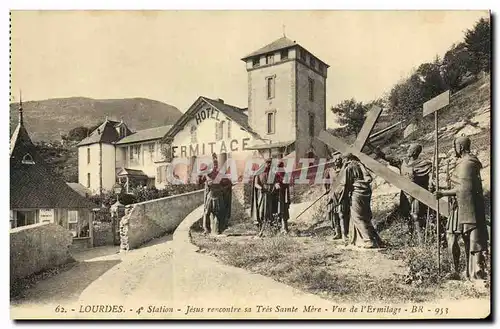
[325,156,349,241]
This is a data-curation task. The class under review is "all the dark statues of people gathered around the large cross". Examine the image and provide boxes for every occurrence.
[199,137,488,279]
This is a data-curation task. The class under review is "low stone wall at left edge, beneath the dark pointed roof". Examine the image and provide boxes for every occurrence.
[10,223,74,285]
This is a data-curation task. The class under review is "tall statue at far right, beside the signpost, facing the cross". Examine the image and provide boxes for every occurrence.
[435,137,488,280]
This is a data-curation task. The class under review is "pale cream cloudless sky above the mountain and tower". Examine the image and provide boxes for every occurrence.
[11,11,488,125]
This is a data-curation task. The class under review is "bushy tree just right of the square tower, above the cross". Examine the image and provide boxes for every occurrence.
[331,98,368,135]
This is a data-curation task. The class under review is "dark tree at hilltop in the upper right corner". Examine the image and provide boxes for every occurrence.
[464,18,491,73]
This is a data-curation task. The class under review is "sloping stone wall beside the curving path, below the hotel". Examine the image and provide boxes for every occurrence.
[120,190,204,250]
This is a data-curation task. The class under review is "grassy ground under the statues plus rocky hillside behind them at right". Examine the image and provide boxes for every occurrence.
[192,77,490,303]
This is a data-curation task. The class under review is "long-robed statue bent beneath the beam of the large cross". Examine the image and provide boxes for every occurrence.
[335,153,383,248]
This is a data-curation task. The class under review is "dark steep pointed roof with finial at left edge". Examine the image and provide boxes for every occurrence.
[10,120,96,209]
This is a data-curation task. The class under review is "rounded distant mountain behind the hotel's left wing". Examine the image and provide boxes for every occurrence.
[10,97,182,141]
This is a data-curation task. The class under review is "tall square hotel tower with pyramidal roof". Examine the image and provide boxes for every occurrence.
[242,36,329,159]
